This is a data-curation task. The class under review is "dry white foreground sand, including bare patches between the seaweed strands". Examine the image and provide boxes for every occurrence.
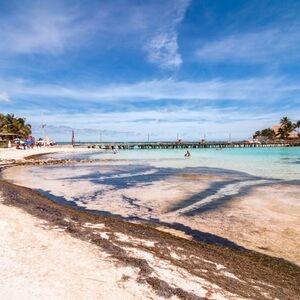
[0,195,241,300]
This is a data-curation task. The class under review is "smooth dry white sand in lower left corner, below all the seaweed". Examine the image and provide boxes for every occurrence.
[0,198,159,300]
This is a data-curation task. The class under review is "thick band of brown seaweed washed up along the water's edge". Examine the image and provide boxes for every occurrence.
[0,180,300,299]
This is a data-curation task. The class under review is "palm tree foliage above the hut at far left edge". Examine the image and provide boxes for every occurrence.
[0,113,31,138]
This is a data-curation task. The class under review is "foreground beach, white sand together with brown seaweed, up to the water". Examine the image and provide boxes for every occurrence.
[0,181,300,299]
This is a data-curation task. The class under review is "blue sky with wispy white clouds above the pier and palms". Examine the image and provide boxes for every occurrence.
[0,0,300,141]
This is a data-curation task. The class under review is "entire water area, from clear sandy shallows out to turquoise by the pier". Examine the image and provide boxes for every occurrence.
[3,148,300,263]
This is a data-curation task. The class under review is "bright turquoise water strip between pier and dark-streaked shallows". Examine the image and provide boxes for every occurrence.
[49,147,300,180]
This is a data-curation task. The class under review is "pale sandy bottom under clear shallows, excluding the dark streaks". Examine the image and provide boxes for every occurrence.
[3,164,300,264]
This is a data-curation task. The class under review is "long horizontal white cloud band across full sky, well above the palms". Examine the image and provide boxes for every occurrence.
[0,77,300,103]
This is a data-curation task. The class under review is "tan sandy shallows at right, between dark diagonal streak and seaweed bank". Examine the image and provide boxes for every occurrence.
[183,184,300,265]
